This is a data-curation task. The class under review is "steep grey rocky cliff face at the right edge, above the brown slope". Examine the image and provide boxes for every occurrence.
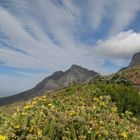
[129,52,140,67]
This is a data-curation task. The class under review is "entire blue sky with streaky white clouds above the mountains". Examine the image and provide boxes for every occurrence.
[0,0,140,97]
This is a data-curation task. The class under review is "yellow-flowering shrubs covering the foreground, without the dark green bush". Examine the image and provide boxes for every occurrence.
[0,92,140,140]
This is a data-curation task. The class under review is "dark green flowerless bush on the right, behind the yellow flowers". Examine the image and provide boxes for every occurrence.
[91,82,140,116]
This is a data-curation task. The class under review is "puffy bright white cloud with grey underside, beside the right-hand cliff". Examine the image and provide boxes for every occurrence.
[95,30,140,66]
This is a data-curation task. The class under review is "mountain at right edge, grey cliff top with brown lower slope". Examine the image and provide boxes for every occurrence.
[120,52,140,86]
